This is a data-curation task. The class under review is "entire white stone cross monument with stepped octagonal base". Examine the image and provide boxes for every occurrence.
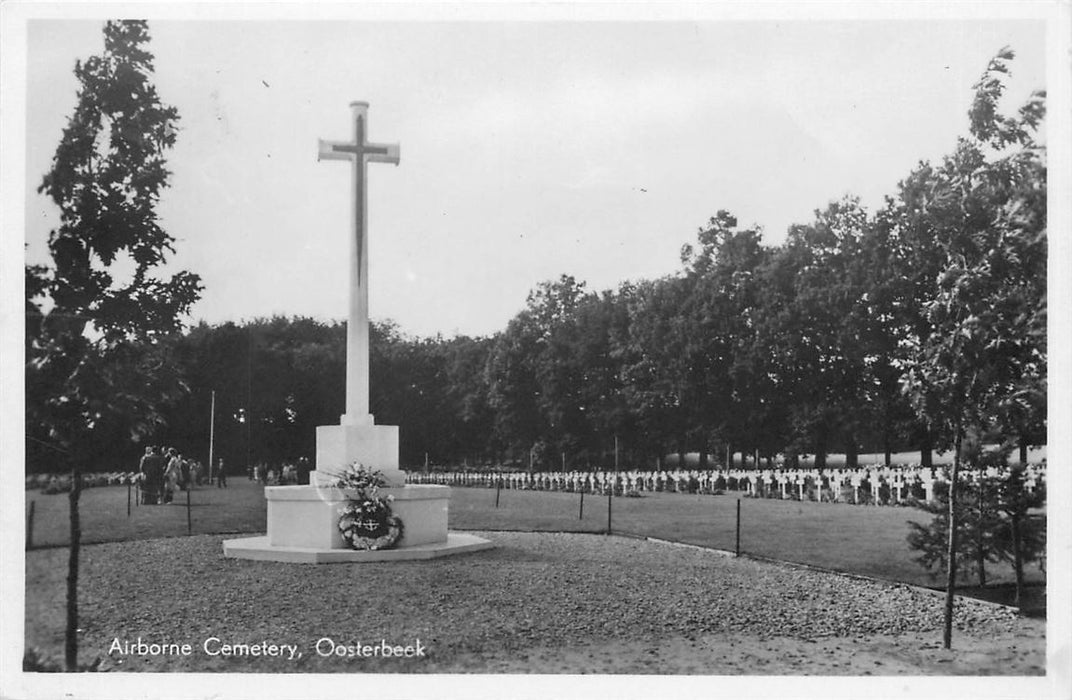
[223,102,492,564]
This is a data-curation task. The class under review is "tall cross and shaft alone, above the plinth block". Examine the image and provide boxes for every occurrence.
[316,102,399,425]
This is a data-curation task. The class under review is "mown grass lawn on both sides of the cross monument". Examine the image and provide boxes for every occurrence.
[26,478,1045,607]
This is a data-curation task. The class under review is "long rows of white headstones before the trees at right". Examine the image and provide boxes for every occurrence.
[407,464,1045,505]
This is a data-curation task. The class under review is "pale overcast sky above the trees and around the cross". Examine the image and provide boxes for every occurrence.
[18,5,1045,336]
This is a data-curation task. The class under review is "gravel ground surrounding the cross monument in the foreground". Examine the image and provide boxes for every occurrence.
[26,532,1045,675]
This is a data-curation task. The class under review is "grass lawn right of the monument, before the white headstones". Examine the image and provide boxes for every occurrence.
[450,489,1045,586]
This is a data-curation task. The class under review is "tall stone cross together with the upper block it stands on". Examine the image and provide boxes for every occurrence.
[311,102,404,486]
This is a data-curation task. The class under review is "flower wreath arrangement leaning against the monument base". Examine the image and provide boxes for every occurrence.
[334,463,403,550]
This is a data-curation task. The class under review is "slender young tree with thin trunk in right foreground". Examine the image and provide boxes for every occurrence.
[904,49,1046,647]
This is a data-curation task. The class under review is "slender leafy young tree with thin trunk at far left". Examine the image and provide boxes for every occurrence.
[27,21,200,671]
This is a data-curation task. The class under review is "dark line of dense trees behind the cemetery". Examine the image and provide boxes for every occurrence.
[29,51,1046,480]
